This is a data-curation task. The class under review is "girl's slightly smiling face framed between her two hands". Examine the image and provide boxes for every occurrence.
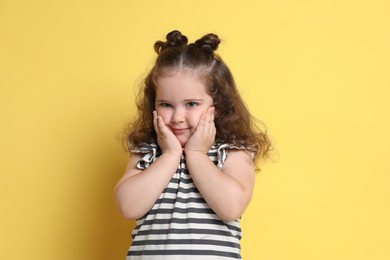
[155,70,213,147]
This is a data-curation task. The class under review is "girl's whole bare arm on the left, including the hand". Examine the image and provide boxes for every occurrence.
[115,112,183,219]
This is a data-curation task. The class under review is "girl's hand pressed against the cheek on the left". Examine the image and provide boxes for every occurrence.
[153,111,183,155]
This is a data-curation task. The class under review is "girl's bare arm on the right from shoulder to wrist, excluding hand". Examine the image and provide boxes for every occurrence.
[186,150,255,221]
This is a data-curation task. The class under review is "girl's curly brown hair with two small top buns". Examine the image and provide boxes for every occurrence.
[124,31,271,159]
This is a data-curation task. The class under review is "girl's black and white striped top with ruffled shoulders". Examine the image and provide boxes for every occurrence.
[126,144,241,260]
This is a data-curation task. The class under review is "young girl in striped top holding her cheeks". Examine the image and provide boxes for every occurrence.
[115,31,270,260]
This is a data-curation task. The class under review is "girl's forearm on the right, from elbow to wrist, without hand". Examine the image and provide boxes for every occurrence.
[186,152,251,220]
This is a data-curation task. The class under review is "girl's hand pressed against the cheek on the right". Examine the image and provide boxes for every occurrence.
[185,106,216,154]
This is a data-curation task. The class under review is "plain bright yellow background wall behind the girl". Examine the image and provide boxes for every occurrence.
[0,0,390,260]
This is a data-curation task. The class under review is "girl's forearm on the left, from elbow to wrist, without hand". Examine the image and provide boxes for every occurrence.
[115,153,181,219]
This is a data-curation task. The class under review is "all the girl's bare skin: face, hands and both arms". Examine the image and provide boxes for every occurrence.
[115,70,255,221]
